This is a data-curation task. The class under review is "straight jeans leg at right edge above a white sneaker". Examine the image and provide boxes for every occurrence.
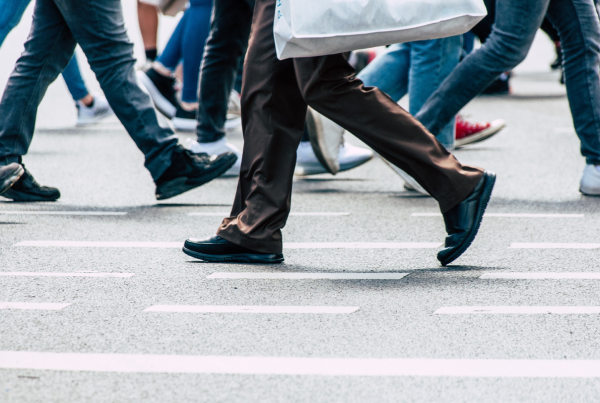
[548,0,600,165]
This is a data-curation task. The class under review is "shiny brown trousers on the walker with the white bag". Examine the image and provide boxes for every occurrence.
[217,0,483,253]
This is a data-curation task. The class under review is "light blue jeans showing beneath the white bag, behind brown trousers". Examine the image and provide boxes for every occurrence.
[357,36,462,149]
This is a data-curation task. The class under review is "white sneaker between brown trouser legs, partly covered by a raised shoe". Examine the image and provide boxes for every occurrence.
[294,141,373,176]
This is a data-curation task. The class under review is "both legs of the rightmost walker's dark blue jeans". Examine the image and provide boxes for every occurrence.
[416,0,600,165]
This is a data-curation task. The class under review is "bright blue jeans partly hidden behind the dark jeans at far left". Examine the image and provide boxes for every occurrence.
[0,0,89,101]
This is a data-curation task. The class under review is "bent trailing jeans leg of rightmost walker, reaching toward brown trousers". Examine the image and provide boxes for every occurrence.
[416,0,549,134]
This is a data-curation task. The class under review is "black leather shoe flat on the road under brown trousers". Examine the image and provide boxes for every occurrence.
[183,235,283,263]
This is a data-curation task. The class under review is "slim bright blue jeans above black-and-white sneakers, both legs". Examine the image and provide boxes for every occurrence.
[158,0,212,102]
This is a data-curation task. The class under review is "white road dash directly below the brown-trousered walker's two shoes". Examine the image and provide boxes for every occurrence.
[206,273,409,280]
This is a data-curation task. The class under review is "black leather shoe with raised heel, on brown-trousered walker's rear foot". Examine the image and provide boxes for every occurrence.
[438,171,496,266]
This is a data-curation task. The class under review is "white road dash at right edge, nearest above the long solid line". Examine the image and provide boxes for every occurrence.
[434,306,600,315]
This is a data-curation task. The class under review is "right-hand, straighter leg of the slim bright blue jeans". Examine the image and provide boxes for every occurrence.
[181,0,213,102]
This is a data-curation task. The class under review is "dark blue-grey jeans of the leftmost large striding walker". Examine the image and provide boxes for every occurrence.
[0,0,177,180]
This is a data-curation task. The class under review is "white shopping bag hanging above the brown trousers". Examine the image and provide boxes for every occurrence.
[273,0,487,59]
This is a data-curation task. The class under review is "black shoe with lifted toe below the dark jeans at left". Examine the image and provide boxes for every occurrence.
[156,145,237,200]
